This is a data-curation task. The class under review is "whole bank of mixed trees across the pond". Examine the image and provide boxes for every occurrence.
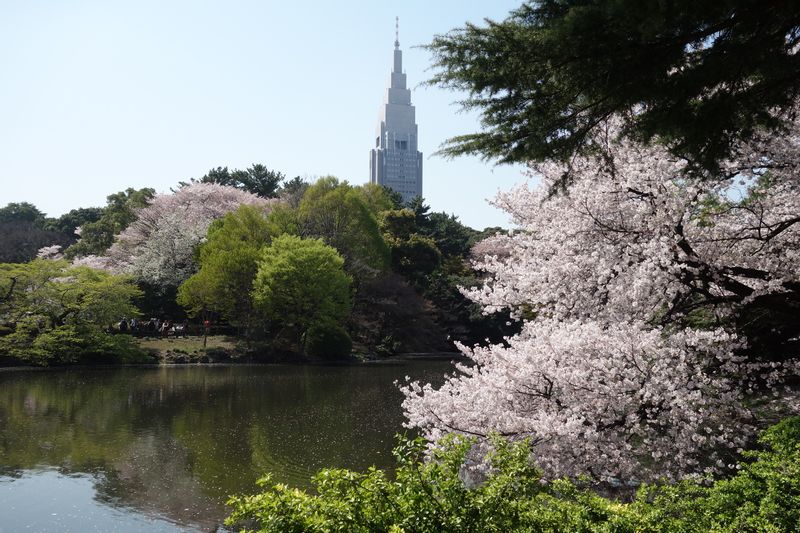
[0,164,514,364]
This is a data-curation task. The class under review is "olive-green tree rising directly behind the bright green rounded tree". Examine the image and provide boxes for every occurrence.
[297,176,389,277]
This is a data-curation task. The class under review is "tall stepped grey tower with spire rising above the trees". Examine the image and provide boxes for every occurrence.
[369,19,422,202]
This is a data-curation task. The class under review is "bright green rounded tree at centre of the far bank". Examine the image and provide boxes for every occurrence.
[252,235,352,350]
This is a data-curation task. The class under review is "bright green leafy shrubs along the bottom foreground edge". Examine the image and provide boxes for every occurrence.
[227,418,800,533]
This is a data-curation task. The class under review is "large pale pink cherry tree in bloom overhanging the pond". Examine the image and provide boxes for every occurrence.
[403,120,800,479]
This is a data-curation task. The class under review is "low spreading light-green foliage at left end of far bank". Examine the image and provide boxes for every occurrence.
[0,260,141,365]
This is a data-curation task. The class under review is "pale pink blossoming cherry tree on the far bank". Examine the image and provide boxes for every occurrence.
[108,183,277,287]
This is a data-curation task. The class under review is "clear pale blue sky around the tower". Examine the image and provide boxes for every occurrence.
[0,0,524,228]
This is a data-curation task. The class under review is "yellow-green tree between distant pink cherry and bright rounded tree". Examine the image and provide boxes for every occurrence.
[178,205,270,334]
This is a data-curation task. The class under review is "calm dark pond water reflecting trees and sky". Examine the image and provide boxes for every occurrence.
[0,361,452,533]
